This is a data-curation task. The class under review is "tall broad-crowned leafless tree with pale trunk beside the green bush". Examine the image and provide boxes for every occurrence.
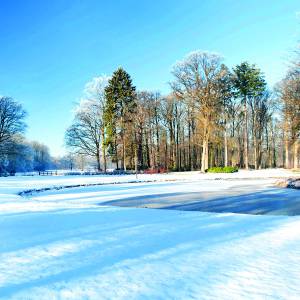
[172,51,222,172]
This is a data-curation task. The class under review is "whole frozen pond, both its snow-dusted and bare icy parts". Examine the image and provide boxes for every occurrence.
[27,179,300,216]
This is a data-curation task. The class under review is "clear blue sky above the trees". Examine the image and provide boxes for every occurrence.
[0,0,300,155]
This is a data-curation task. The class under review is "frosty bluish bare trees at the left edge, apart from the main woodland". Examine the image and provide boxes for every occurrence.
[0,97,52,175]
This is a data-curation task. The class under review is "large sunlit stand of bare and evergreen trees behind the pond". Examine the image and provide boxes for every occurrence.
[66,51,300,171]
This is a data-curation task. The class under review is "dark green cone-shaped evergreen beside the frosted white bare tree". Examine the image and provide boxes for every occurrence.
[104,68,136,171]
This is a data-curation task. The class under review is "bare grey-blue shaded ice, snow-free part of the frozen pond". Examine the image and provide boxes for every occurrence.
[104,188,300,216]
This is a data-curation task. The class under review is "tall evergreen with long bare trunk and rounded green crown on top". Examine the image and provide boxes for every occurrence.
[233,62,266,169]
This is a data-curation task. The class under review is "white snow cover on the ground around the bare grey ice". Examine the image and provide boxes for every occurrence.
[0,170,300,299]
